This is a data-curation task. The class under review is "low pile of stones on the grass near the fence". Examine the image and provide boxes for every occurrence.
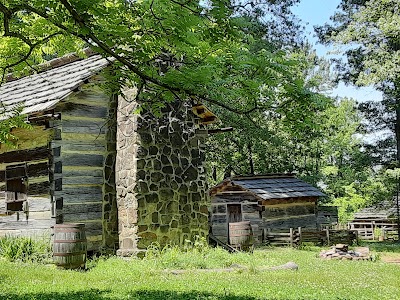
[319,244,371,260]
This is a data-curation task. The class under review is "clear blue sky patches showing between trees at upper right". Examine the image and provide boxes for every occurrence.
[293,0,382,101]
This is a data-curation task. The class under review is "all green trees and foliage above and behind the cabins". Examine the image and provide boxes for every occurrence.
[0,0,400,222]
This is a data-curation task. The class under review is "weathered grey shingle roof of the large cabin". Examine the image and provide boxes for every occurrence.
[0,55,110,114]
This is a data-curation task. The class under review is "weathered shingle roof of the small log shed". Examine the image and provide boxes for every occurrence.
[210,174,326,200]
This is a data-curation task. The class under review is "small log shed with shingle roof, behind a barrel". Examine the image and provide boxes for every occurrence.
[210,174,325,243]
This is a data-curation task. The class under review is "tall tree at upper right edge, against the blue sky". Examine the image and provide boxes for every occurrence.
[316,0,400,163]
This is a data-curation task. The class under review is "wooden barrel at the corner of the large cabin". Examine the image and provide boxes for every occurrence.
[53,223,87,269]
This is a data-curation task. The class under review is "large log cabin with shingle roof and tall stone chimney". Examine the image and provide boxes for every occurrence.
[0,54,216,255]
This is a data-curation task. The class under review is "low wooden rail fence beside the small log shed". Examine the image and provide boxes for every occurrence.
[263,227,358,247]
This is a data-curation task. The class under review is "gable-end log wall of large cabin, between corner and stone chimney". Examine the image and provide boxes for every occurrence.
[50,83,118,251]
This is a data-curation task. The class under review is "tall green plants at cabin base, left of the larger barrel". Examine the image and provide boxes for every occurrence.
[0,236,51,263]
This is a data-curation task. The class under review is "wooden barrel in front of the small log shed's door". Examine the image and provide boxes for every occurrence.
[229,221,253,251]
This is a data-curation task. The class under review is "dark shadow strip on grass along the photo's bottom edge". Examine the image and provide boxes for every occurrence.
[0,289,262,300]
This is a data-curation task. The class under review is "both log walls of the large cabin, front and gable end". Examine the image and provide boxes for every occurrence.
[0,77,118,251]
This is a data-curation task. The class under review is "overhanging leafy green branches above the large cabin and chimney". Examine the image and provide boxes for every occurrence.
[0,0,314,113]
